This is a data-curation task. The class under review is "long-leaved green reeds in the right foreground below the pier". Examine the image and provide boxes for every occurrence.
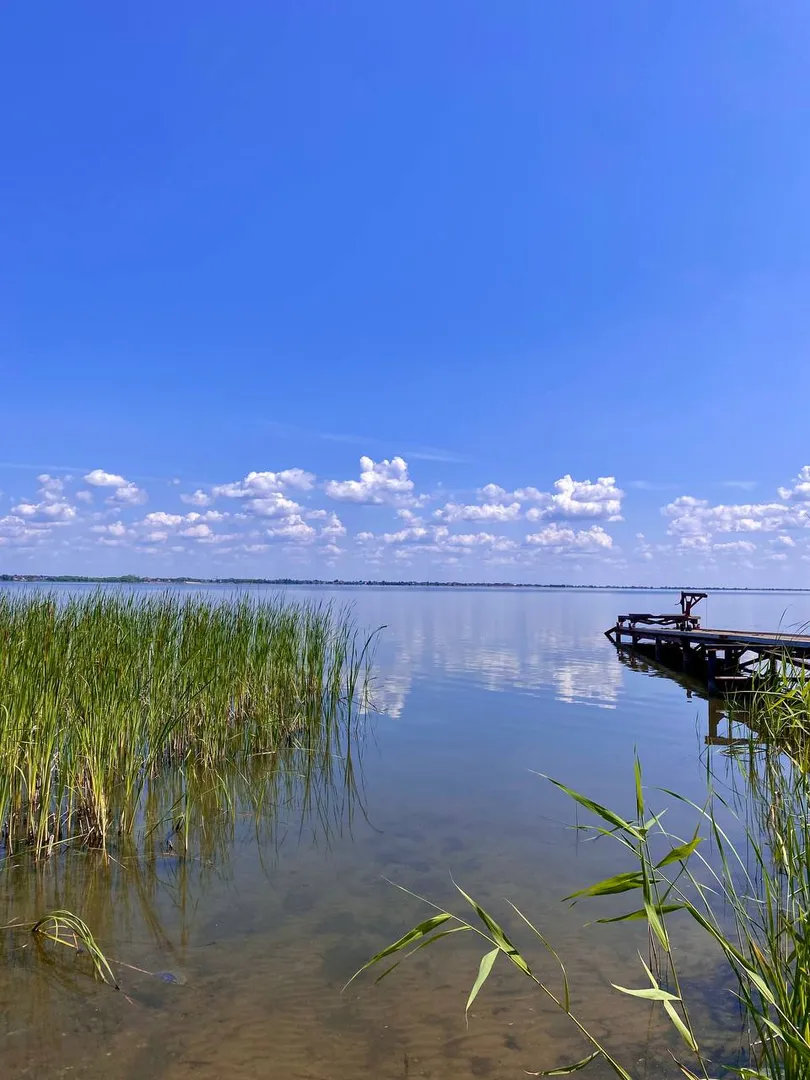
[354,667,810,1080]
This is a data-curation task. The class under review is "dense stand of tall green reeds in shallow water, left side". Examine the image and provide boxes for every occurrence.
[0,591,372,854]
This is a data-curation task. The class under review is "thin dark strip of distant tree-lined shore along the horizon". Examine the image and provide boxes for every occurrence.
[0,573,810,593]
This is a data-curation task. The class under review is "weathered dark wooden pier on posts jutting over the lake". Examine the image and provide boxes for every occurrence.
[605,592,810,693]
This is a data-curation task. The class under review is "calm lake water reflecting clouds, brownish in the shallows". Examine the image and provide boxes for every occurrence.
[0,586,810,1080]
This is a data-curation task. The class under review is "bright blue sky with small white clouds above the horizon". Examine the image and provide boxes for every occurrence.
[0,6,810,585]
